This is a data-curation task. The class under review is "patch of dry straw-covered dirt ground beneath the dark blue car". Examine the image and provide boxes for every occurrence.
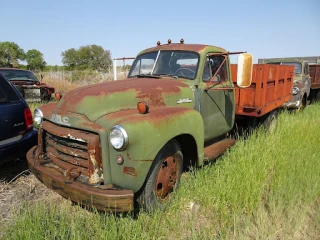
[0,160,64,225]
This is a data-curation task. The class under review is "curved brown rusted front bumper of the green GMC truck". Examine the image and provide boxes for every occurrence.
[27,146,134,212]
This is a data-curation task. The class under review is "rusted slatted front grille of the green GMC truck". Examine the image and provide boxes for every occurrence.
[42,122,102,184]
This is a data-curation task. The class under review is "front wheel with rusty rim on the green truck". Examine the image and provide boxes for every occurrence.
[137,140,183,212]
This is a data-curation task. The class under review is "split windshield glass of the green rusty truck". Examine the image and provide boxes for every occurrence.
[128,50,199,79]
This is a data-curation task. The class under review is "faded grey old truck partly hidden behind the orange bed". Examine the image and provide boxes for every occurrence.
[266,58,311,110]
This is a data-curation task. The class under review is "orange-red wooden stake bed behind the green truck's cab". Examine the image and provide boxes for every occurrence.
[231,64,294,117]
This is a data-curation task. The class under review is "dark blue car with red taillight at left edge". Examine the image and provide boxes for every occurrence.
[0,73,38,161]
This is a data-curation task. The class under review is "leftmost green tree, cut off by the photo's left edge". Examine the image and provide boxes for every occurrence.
[0,42,25,67]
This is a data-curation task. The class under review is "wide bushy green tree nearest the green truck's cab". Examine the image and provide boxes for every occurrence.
[61,44,112,71]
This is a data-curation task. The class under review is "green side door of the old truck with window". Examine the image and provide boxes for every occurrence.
[199,54,235,141]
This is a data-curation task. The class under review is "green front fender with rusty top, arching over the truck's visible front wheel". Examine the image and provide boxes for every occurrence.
[96,106,204,192]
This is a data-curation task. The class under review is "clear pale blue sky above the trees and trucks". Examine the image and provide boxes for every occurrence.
[0,0,320,65]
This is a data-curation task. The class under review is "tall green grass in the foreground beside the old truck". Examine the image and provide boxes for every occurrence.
[3,104,320,239]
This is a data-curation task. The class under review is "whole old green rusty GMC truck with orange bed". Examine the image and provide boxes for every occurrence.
[27,40,294,212]
